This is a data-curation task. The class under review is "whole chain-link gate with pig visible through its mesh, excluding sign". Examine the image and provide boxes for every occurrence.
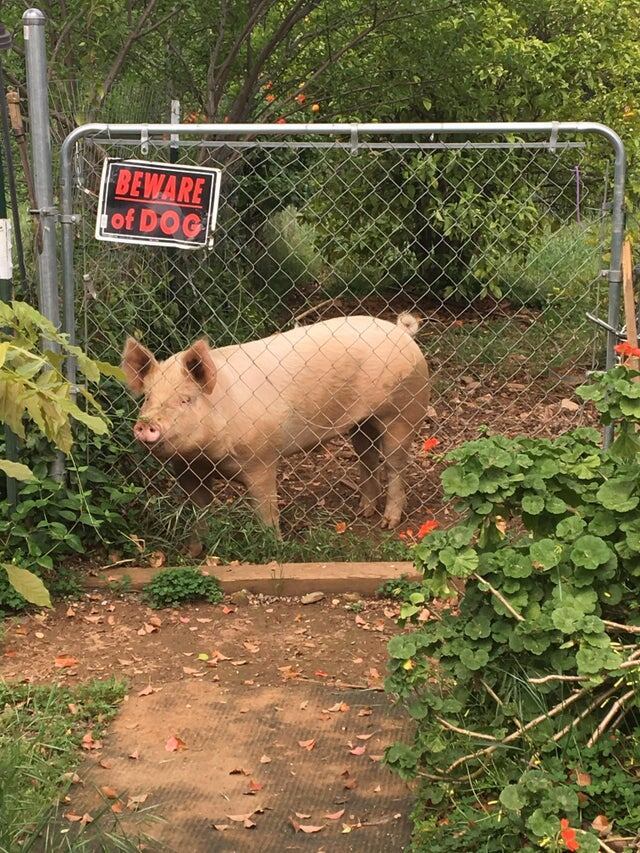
[62,124,624,557]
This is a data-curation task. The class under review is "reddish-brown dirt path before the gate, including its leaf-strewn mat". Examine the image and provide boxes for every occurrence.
[0,594,412,853]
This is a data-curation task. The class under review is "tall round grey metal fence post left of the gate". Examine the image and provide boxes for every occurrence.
[22,9,64,480]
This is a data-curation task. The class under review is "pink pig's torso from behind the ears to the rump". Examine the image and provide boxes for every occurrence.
[213,316,427,453]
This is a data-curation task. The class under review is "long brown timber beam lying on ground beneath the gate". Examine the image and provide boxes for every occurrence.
[85,562,420,596]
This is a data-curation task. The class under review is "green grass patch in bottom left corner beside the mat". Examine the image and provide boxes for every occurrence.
[0,680,154,853]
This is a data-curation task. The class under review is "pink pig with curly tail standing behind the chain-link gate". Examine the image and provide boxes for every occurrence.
[122,314,429,535]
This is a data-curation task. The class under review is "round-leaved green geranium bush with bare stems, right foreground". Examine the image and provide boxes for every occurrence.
[386,366,640,853]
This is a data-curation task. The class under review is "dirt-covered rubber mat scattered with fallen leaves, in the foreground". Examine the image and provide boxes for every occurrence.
[72,681,413,853]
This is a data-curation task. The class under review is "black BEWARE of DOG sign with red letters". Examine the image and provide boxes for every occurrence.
[96,159,220,249]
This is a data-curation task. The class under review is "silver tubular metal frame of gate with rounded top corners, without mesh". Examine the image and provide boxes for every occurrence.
[60,122,626,392]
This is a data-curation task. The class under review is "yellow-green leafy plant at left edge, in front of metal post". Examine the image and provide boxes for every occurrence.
[0,302,121,606]
